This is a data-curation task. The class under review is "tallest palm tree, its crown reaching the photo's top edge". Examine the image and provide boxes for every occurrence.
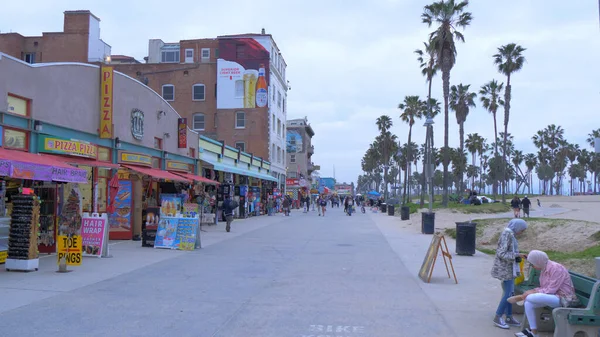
[421,0,472,206]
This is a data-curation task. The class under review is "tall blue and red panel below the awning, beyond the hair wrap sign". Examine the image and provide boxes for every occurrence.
[108,180,133,240]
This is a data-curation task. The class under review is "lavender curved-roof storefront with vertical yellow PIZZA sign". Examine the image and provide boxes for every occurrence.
[0,53,199,252]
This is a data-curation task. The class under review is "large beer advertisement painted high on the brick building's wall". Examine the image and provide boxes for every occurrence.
[217,38,270,109]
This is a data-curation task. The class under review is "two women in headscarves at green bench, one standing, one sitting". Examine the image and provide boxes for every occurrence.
[491,219,578,337]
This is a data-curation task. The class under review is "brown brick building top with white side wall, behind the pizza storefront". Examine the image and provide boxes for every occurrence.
[0,11,111,63]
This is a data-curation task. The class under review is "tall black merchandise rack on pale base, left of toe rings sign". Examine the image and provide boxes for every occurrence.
[5,194,40,271]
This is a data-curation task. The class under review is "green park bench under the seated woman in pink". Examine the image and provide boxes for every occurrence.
[515,268,600,337]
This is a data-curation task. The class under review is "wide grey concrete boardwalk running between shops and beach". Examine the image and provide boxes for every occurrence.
[0,209,536,337]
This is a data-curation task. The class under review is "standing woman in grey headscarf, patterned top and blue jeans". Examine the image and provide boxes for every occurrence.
[492,219,527,329]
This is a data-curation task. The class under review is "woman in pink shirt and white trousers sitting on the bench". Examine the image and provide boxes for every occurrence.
[509,250,577,337]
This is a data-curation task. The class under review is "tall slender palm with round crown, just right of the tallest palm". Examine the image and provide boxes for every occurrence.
[494,43,525,202]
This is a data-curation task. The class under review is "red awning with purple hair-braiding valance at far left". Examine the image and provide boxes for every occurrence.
[0,148,88,184]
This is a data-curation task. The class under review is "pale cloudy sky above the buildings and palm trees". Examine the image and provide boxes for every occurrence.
[0,0,600,183]
